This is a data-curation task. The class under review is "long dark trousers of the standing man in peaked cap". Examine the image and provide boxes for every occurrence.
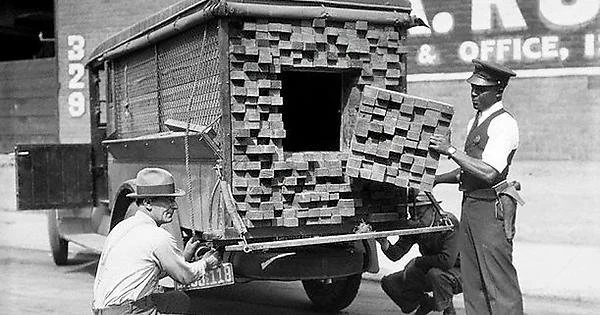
[458,197,523,315]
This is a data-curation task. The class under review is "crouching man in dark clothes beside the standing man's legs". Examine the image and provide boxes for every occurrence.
[377,207,462,314]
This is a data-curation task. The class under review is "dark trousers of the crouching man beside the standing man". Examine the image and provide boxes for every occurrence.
[381,265,462,313]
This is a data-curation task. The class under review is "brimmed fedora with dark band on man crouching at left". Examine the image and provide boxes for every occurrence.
[127,167,185,198]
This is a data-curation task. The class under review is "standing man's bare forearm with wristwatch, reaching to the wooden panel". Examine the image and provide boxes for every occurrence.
[429,135,500,185]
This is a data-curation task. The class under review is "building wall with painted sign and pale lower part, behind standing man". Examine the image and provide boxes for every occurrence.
[407,0,600,161]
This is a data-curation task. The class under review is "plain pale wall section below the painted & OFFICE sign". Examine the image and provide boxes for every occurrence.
[408,76,600,161]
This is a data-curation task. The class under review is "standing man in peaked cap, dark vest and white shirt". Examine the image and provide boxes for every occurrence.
[430,59,523,315]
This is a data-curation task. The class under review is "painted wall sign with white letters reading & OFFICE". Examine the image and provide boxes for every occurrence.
[407,0,600,74]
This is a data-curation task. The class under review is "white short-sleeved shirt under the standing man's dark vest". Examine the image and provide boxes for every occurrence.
[467,101,519,173]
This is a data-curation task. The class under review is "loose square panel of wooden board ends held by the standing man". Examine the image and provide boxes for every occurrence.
[346,86,454,191]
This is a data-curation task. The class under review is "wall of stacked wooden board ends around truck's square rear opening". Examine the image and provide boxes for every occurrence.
[229,19,406,227]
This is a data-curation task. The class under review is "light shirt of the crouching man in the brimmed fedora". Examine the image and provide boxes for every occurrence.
[92,211,206,309]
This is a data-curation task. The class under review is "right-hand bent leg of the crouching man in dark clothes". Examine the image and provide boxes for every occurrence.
[427,268,462,311]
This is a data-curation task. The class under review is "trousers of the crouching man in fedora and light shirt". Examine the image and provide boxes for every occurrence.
[93,291,190,315]
